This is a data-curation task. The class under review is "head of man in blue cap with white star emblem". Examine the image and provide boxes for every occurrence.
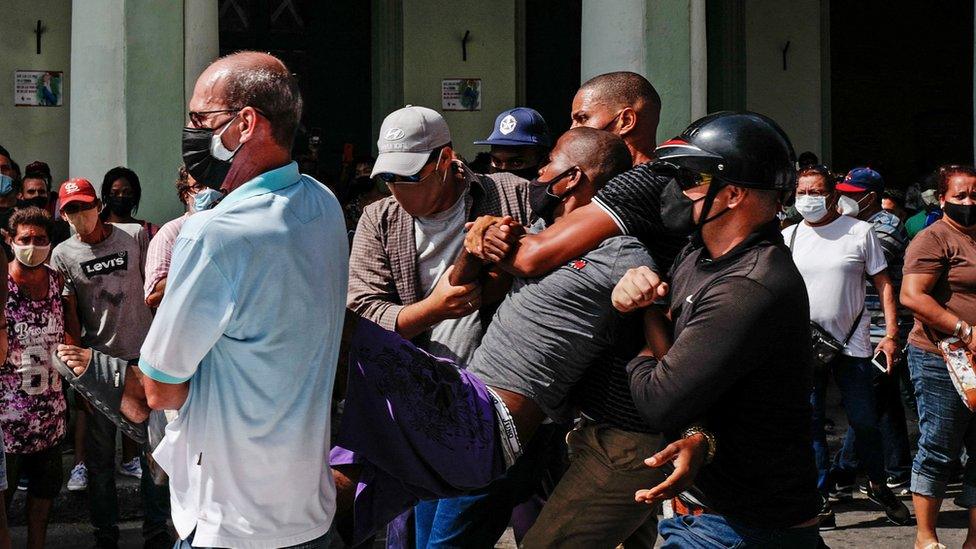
[474,107,552,179]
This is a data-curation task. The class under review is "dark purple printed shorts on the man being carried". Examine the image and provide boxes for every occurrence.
[330,319,505,544]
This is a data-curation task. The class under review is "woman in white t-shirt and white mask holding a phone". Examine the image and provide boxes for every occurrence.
[783,166,911,529]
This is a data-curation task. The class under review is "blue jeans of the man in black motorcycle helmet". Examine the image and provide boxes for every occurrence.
[657,514,821,549]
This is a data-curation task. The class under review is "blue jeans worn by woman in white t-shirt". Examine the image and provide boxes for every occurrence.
[810,355,885,495]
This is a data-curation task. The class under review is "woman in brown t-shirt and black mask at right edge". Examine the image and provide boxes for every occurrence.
[901,166,976,549]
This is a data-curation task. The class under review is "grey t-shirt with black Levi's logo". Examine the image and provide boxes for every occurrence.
[51,223,152,360]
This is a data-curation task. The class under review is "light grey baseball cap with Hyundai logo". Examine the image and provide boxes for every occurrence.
[370,105,451,177]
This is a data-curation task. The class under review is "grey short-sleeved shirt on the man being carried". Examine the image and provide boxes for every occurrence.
[468,231,656,421]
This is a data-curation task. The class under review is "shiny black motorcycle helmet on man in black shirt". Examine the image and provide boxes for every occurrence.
[655,111,796,191]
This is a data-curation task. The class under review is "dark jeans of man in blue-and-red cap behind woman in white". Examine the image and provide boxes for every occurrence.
[834,363,914,481]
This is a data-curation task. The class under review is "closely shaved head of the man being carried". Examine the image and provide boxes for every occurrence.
[556,126,632,189]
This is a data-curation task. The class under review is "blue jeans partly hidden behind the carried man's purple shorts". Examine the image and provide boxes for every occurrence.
[414,424,566,548]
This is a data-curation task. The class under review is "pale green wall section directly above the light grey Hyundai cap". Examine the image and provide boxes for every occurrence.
[398,0,517,160]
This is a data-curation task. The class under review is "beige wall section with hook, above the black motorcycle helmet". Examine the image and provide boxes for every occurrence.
[745,0,830,158]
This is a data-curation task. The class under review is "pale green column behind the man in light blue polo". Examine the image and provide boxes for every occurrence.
[69,0,218,223]
